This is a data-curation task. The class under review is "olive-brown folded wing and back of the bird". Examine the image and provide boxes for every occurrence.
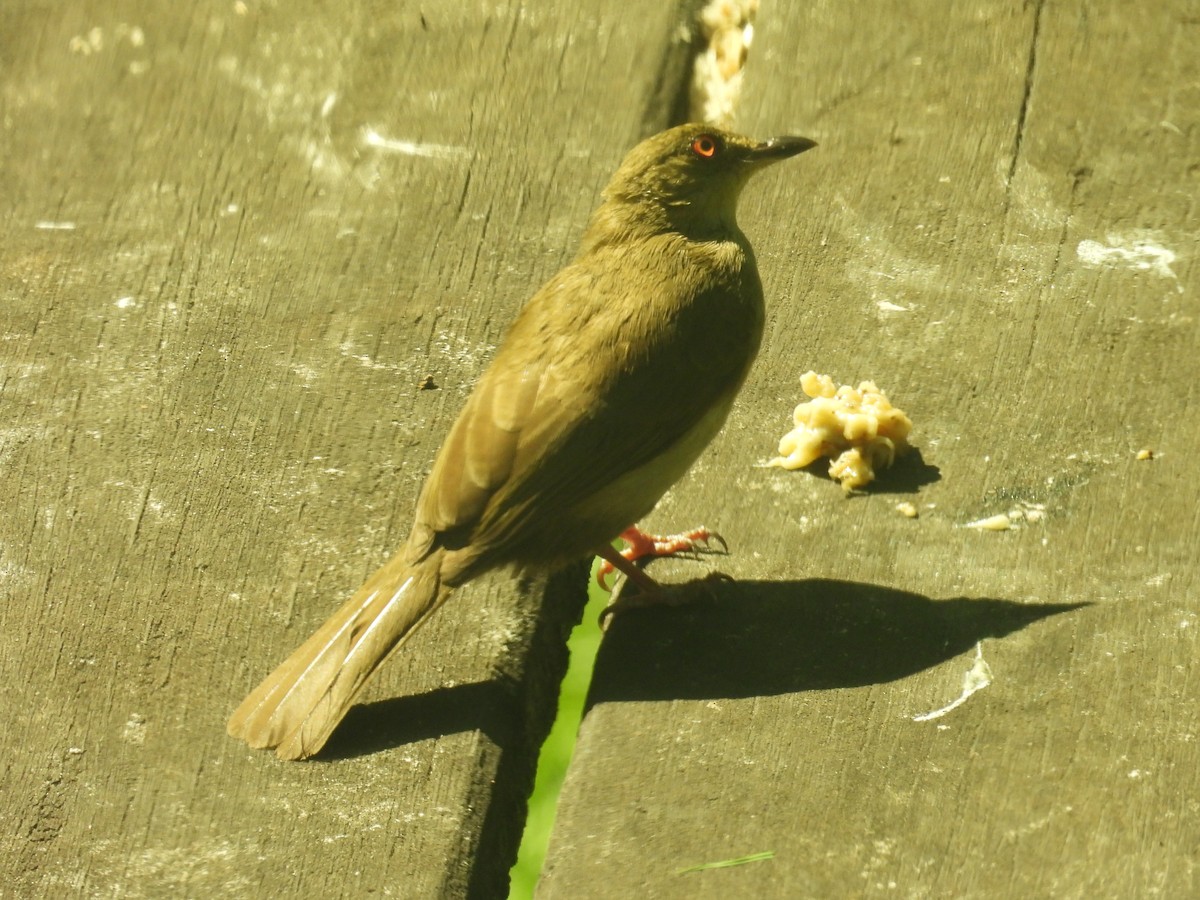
[416,241,762,571]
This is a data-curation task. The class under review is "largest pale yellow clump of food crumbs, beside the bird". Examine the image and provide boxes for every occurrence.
[767,371,912,491]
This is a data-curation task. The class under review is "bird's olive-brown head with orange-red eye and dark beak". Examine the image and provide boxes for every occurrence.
[604,124,816,236]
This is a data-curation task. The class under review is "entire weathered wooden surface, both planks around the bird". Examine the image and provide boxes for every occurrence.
[0,0,1200,898]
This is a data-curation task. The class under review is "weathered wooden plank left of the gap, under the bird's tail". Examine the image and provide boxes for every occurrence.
[0,0,700,898]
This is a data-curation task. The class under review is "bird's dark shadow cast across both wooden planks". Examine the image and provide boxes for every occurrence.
[317,578,1088,760]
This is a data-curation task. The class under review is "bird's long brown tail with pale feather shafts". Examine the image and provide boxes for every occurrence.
[228,552,450,760]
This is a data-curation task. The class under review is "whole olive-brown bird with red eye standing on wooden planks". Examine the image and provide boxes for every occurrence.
[228,124,816,760]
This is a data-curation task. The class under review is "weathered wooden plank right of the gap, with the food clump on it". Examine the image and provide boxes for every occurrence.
[539,0,1200,899]
